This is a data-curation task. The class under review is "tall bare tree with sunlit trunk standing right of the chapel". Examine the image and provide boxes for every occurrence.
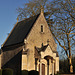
[50,0,75,73]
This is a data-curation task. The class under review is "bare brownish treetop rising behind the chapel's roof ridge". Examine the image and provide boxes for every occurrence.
[17,0,48,20]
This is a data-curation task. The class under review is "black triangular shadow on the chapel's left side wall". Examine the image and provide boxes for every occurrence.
[2,50,22,75]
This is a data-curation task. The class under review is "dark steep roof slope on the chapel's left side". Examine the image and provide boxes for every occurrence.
[3,14,39,47]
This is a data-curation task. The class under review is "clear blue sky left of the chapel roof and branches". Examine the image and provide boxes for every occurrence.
[0,0,27,48]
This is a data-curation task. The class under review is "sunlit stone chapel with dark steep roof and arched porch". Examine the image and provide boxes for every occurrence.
[0,11,59,75]
